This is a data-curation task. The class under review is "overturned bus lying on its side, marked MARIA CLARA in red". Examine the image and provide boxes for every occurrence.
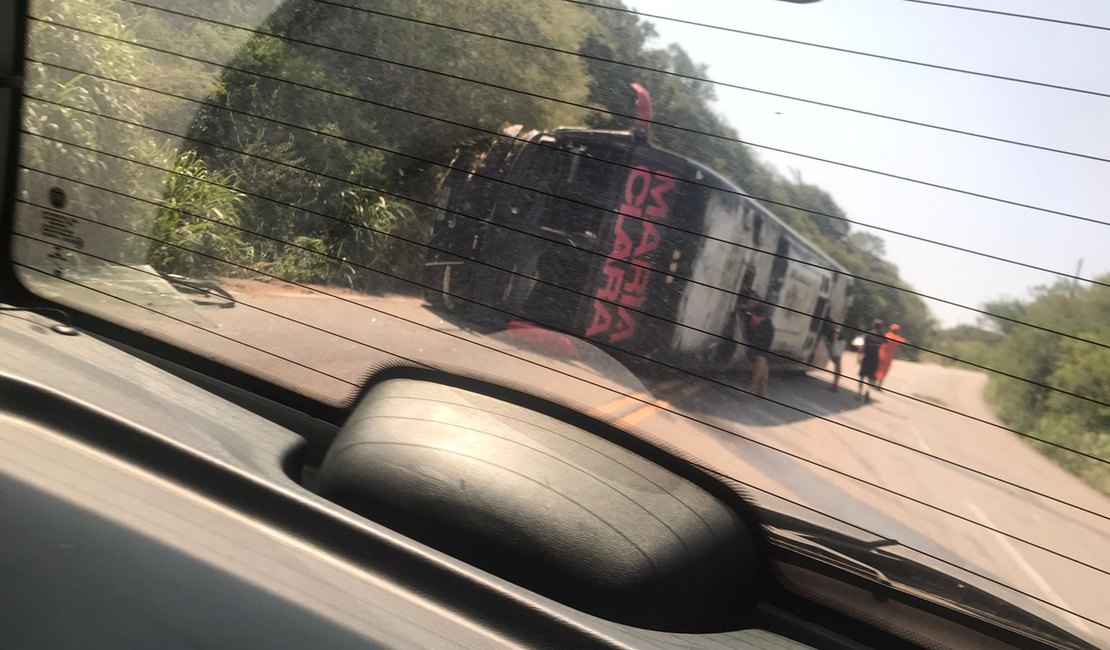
[424,123,851,370]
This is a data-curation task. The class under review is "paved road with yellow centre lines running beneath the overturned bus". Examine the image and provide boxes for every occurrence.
[30,269,1110,644]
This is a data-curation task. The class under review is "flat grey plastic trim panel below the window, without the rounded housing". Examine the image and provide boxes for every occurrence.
[0,313,804,650]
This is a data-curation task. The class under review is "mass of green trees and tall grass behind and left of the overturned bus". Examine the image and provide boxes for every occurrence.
[28,0,932,321]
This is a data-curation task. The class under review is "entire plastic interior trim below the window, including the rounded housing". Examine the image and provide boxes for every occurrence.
[0,311,1087,649]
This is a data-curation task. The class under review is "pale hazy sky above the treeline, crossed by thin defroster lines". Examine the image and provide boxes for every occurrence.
[627,0,1110,326]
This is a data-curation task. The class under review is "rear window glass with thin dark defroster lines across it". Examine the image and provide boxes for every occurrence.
[12,0,1110,646]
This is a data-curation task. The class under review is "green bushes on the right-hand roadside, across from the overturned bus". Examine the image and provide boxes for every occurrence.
[937,276,1110,494]
